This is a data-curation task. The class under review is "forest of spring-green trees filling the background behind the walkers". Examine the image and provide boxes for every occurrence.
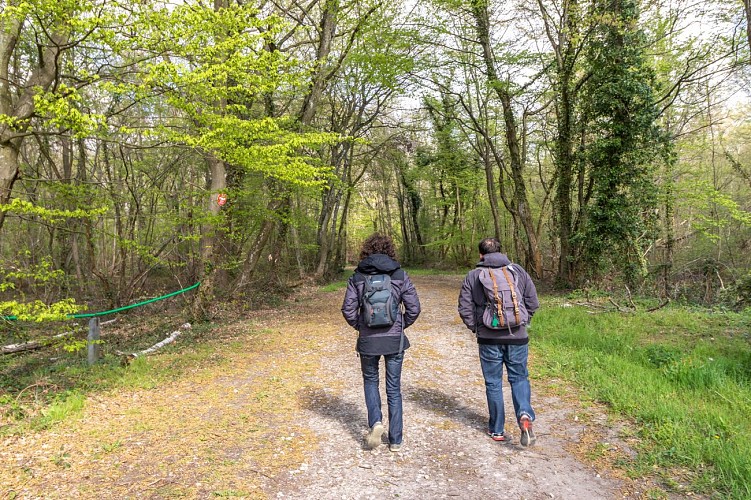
[0,0,751,320]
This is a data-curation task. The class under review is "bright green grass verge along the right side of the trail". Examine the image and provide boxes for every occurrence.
[531,304,751,498]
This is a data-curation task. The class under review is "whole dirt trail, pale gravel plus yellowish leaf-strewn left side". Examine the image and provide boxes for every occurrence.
[0,276,633,499]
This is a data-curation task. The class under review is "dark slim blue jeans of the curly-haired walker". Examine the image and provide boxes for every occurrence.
[360,352,404,444]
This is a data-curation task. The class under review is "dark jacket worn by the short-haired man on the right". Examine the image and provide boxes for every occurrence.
[459,253,540,344]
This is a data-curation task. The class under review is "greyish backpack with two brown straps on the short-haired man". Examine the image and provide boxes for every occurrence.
[480,265,529,330]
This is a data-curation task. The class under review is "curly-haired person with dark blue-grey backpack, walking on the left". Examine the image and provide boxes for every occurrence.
[342,233,420,452]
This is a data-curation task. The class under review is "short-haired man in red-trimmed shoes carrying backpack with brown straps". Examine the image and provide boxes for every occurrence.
[458,238,540,446]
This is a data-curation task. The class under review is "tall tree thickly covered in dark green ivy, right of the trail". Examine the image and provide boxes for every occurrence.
[578,0,664,282]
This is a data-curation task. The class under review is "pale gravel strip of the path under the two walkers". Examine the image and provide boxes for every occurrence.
[274,276,625,499]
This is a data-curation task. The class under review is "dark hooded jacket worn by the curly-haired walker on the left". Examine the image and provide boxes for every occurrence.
[342,254,420,355]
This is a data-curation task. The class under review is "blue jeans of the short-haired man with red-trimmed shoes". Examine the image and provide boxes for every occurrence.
[478,344,535,434]
